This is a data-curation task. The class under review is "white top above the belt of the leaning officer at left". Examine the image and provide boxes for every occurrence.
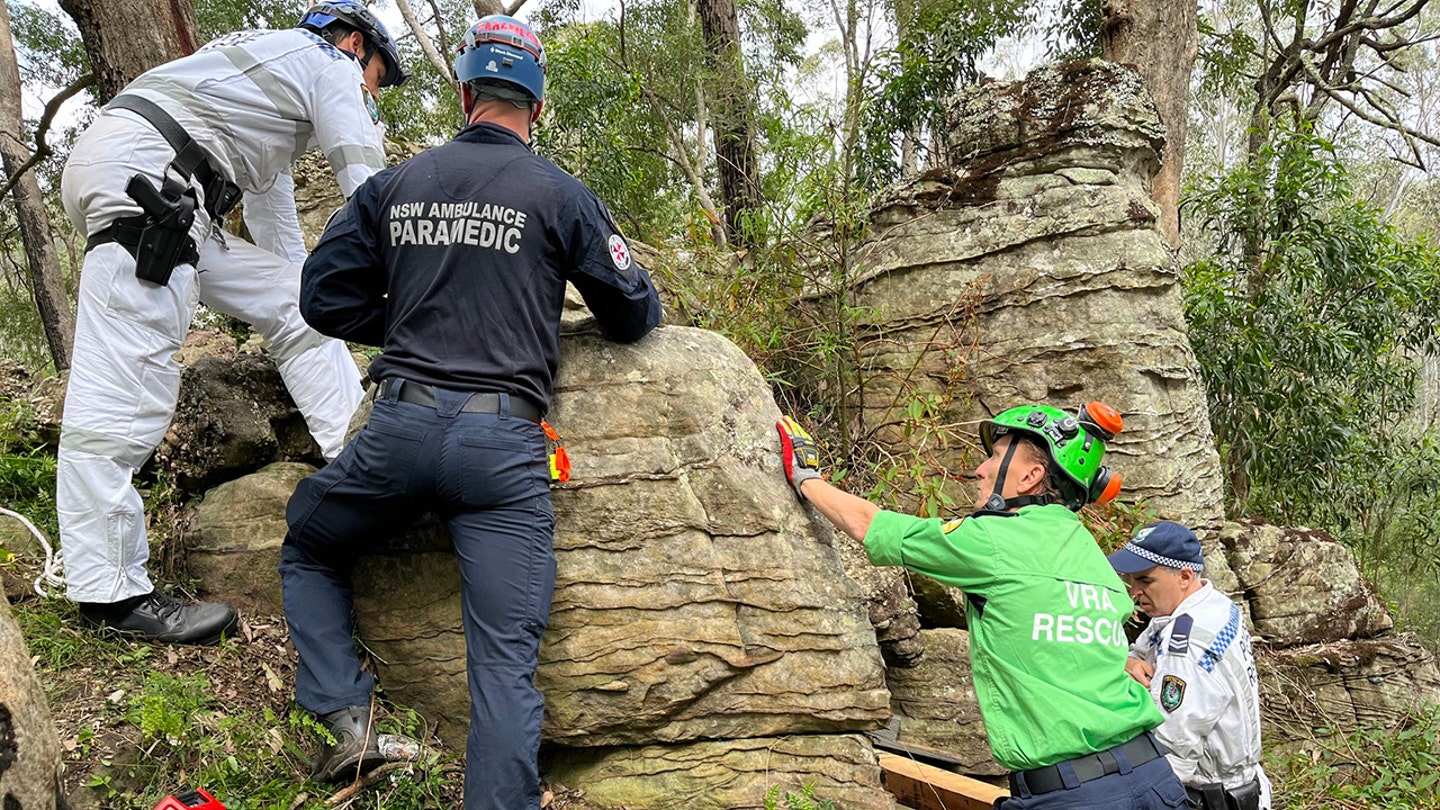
[121,29,384,261]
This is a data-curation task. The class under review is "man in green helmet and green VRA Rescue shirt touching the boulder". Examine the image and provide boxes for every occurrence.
[776,402,1185,810]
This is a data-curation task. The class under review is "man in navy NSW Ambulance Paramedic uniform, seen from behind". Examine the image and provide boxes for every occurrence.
[281,16,661,795]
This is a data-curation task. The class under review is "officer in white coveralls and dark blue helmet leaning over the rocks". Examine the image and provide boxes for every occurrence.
[56,0,405,644]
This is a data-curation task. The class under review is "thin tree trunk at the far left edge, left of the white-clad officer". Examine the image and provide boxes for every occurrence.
[0,3,75,370]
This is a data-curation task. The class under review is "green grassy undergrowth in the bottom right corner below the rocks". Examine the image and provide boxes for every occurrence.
[1266,706,1440,810]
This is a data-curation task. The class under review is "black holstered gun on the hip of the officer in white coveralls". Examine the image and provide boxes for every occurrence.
[85,174,200,287]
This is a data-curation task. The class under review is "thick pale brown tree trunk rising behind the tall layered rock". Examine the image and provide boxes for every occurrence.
[1100,0,1200,248]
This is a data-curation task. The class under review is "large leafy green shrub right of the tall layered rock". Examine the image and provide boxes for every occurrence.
[1185,121,1440,540]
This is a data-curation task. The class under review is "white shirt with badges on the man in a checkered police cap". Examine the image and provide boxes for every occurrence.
[1130,581,1270,810]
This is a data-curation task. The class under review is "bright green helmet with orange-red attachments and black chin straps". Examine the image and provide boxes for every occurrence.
[981,402,1123,512]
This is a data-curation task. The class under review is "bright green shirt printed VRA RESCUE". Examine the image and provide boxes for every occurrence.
[865,504,1164,771]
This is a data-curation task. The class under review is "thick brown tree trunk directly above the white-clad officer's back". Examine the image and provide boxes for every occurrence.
[60,0,200,104]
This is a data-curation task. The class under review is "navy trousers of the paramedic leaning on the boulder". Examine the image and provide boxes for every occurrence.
[279,383,554,810]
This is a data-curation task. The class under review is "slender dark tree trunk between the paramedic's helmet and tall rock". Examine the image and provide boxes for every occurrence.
[697,0,760,246]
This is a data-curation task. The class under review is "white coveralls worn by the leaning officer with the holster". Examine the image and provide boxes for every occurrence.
[56,29,384,602]
